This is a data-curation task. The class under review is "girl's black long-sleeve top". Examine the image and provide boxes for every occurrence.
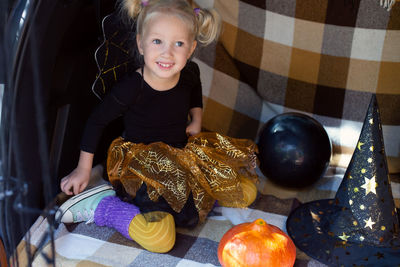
[81,62,203,153]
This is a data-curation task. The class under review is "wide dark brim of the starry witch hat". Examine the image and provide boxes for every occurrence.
[286,199,400,266]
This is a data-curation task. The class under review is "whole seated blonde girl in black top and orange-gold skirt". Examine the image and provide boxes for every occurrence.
[56,0,257,252]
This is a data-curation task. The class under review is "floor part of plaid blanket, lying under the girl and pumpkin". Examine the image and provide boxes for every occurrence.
[17,167,400,267]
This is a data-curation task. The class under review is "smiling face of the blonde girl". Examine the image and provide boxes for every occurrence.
[136,13,196,90]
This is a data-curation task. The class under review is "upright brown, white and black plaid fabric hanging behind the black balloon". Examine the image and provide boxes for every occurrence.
[195,0,400,168]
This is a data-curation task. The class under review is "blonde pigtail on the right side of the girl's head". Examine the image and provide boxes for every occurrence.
[195,9,221,45]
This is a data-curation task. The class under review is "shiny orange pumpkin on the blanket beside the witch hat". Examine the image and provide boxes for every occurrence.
[218,219,296,267]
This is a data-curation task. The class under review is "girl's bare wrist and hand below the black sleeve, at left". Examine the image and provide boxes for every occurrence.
[60,150,94,195]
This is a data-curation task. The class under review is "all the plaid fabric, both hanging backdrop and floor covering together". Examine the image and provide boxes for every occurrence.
[17,0,400,267]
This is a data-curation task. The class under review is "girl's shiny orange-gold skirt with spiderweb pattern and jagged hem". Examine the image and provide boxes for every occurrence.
[107,132,258,221]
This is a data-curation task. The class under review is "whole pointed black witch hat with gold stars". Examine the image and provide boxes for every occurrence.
[286,95,400,266]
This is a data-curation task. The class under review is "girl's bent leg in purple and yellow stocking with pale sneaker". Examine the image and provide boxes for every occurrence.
[56,185,175,253]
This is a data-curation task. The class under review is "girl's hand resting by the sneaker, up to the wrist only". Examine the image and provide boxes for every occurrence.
[60,167,91,195]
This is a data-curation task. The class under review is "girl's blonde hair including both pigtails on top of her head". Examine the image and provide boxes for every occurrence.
[120,0,221,45]
